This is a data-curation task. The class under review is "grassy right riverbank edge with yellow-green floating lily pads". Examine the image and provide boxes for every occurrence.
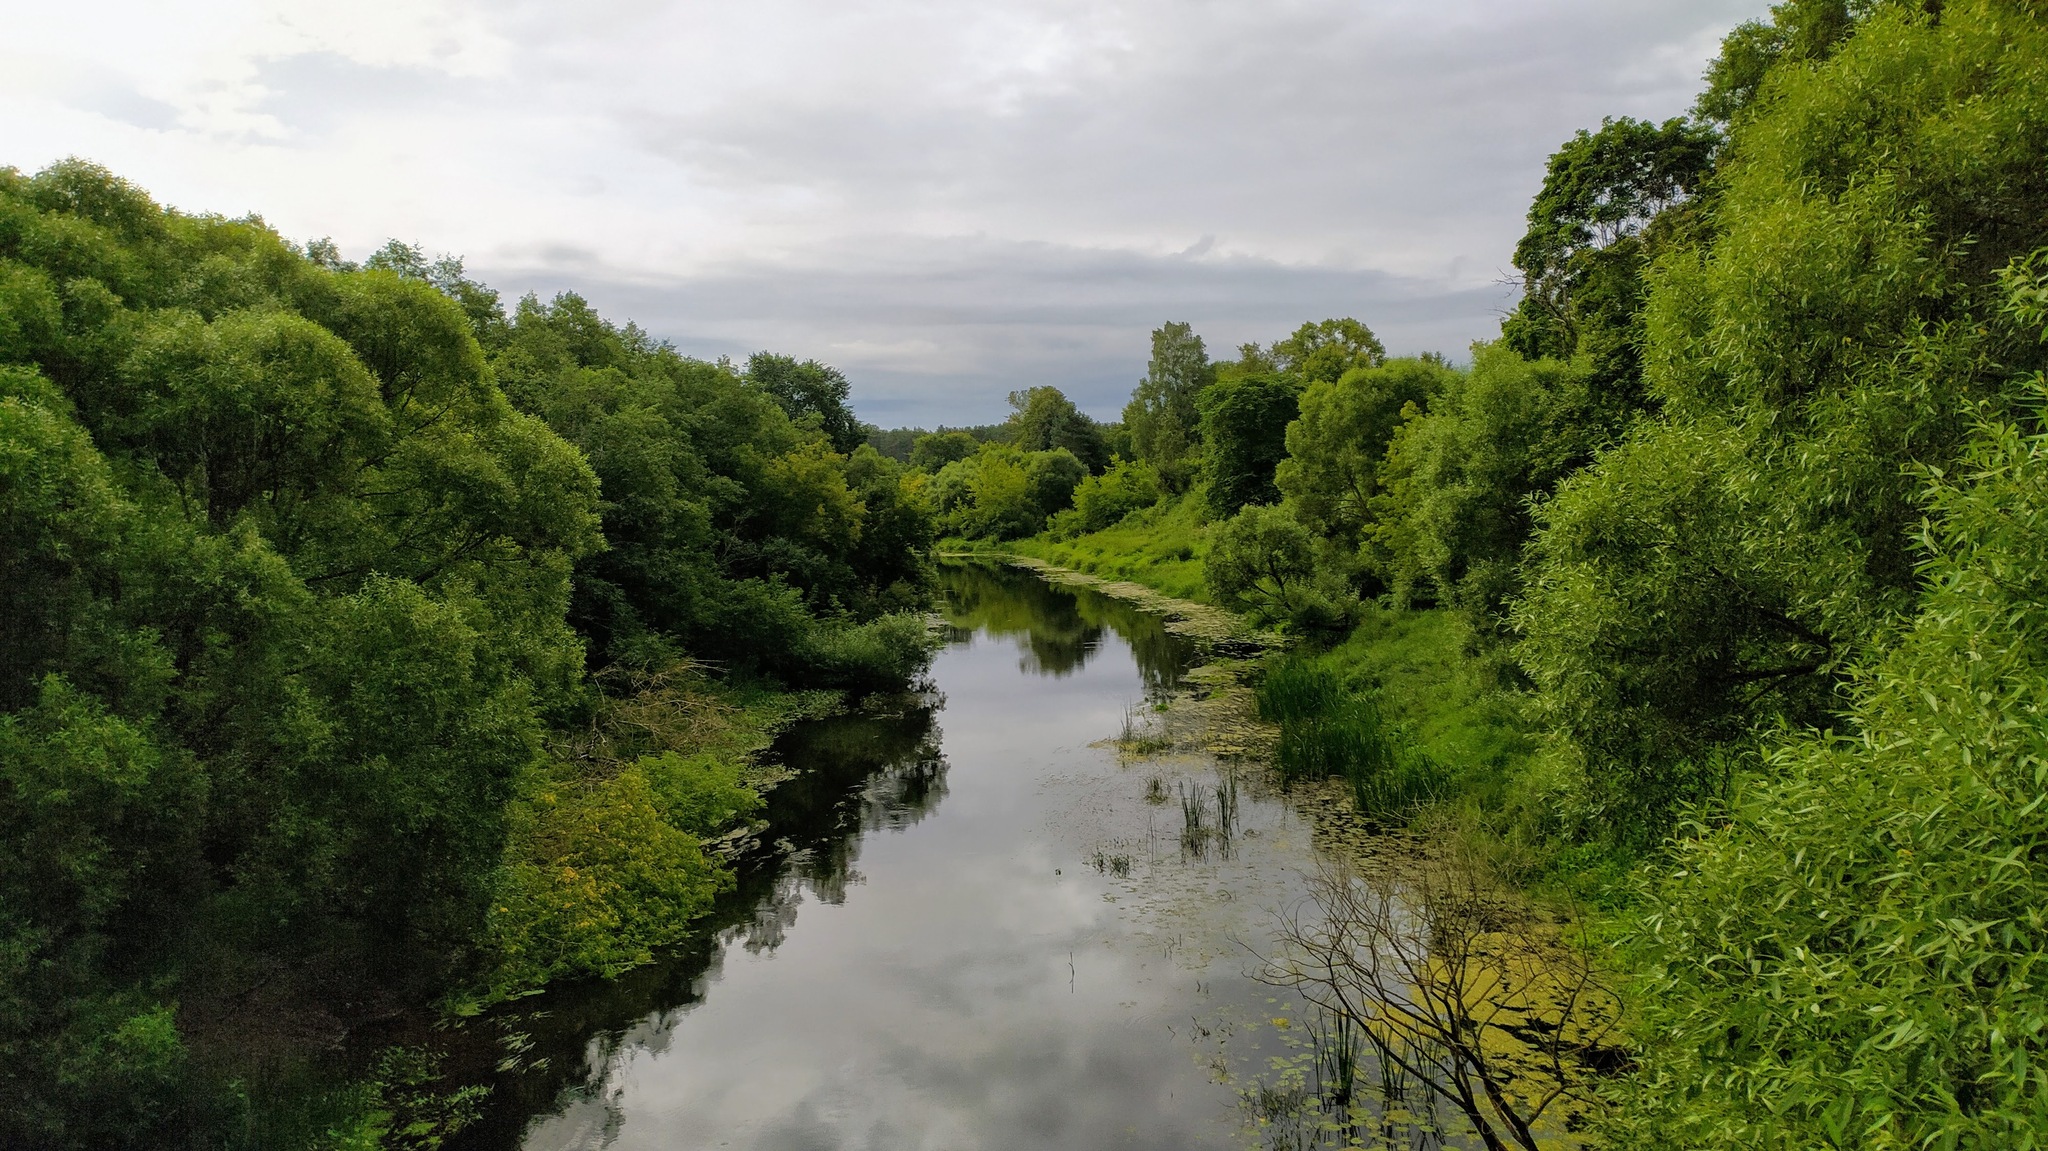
[950,549,1628,1147]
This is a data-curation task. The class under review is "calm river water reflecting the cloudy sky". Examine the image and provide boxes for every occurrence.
[461,565,1343,1151]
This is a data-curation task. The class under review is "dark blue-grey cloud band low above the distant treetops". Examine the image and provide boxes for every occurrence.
[475,238,1513,424]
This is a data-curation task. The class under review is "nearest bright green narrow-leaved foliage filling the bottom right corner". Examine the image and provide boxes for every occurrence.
[1614,362,2048,1147]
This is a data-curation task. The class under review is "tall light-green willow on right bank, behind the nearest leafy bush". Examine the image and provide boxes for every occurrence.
[1516,2,2048,834]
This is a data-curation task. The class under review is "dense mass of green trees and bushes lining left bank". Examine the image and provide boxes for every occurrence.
[0,160,936,1147]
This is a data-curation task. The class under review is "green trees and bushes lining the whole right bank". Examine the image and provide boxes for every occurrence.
[918,0,2048,1149]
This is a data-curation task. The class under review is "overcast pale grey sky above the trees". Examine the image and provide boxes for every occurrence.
[0,0,1765,426]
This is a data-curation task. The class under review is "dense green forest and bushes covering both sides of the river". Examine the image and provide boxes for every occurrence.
[12,0,2048,1149]
